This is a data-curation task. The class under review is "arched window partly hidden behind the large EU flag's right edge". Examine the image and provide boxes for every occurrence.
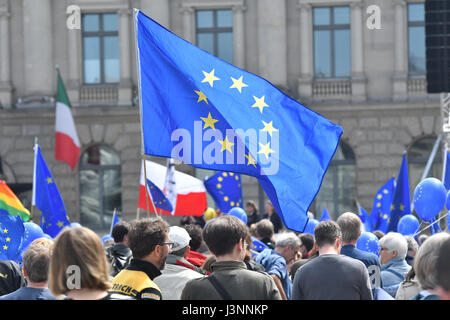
[310,141,356,220]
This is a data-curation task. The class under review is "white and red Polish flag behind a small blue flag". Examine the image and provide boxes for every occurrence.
[138,160,207,216]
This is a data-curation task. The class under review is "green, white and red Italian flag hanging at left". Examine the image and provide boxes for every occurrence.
[55,71,81,171]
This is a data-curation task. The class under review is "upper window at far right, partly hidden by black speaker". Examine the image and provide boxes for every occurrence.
[408,3,426,75]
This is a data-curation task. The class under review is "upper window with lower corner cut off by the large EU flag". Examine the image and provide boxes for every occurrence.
[196,9,233,63]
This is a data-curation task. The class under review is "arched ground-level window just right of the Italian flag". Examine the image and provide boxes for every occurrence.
[80,145,122,230]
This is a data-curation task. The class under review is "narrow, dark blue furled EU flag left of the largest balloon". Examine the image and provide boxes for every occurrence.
[387,152,411,232]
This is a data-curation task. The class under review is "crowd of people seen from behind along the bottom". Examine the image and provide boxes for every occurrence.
[0,202,450,300]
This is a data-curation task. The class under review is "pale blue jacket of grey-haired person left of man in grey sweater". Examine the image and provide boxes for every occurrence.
[255,249,292,300]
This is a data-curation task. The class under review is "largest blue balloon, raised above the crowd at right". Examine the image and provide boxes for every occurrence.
[413,178,447,221]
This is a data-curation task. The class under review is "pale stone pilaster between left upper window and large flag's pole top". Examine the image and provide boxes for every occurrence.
[118,8,132,105]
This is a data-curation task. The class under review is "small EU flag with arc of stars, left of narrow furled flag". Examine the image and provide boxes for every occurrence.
[370,177,395,233]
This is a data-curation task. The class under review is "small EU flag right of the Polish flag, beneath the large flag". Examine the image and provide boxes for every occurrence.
[204,172,243,212]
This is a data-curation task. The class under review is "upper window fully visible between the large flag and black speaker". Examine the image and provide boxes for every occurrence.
[313,7,351,78]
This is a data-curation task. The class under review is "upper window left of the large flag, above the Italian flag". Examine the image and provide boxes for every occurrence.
[82,13,120,84]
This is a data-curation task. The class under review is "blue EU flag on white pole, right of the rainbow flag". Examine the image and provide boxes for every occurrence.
[32,144,70,238]
